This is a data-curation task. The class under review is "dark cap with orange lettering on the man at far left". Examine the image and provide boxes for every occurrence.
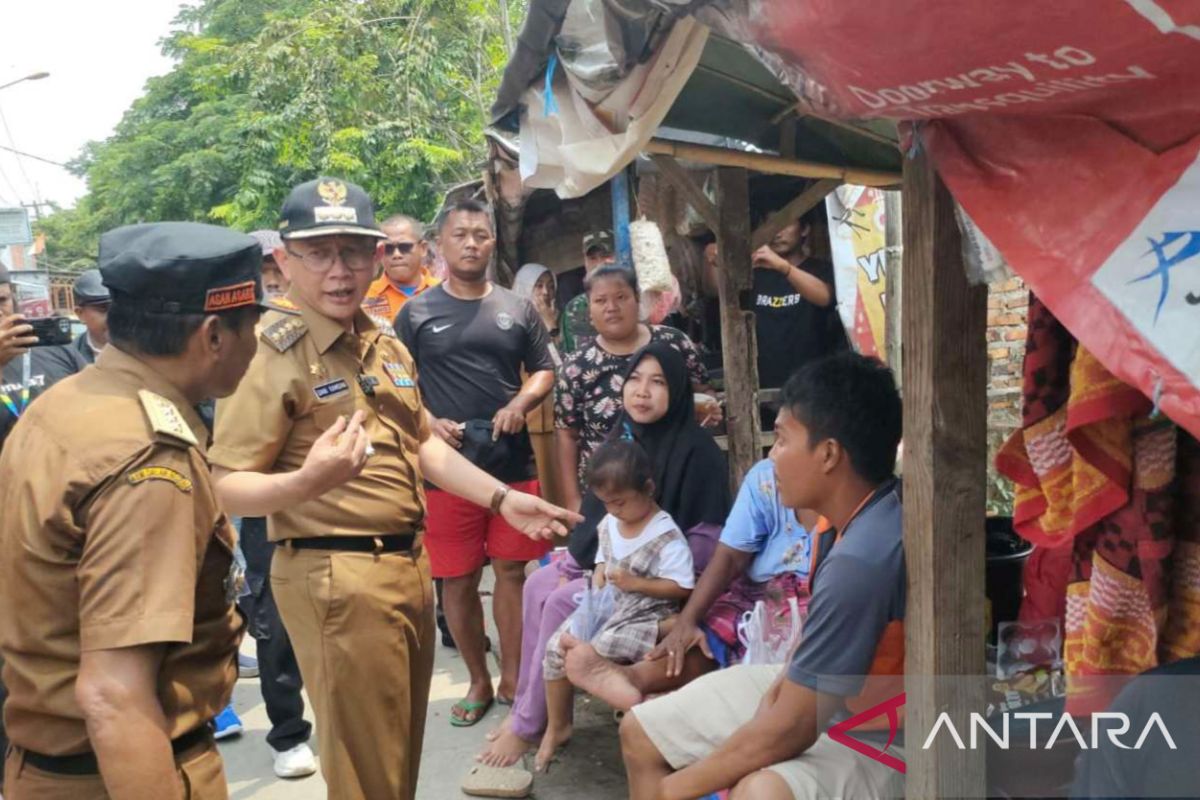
[100,222,263,314]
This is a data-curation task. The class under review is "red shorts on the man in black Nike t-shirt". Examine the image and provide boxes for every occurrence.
[425,480,552,578]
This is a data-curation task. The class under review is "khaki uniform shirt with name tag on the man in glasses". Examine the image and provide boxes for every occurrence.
[209,291,430,541]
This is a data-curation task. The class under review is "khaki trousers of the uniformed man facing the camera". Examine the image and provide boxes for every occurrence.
[271,545,434,800]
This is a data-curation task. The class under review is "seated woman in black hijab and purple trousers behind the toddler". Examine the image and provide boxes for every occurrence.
[479,342,731,766]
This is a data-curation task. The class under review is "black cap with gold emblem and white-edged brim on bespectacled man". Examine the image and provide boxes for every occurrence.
[280,178,388,239]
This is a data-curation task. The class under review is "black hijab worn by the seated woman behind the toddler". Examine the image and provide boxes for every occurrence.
[568,342,730,570]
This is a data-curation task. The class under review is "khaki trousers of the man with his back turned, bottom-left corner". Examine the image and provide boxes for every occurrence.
[4,741,229,800]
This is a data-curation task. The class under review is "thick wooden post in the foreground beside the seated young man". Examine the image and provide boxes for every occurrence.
[901,152,988,798]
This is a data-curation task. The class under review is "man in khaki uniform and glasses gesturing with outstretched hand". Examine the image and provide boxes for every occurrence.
[210,178,576,800]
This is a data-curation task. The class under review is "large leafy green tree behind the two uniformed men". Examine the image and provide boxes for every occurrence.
[40,0,524,265]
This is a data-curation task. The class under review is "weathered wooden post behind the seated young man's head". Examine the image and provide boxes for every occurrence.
[716,167,762,486]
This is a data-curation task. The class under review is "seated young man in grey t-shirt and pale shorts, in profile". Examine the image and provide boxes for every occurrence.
[620,353,906,800]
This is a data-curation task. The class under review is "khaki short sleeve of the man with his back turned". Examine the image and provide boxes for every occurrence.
[77,445,207,650]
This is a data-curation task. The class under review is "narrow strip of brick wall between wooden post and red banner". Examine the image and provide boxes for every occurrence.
[988,277,1030,513]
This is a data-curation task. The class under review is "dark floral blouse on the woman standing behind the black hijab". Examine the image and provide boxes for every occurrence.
[554,325,708,481]
